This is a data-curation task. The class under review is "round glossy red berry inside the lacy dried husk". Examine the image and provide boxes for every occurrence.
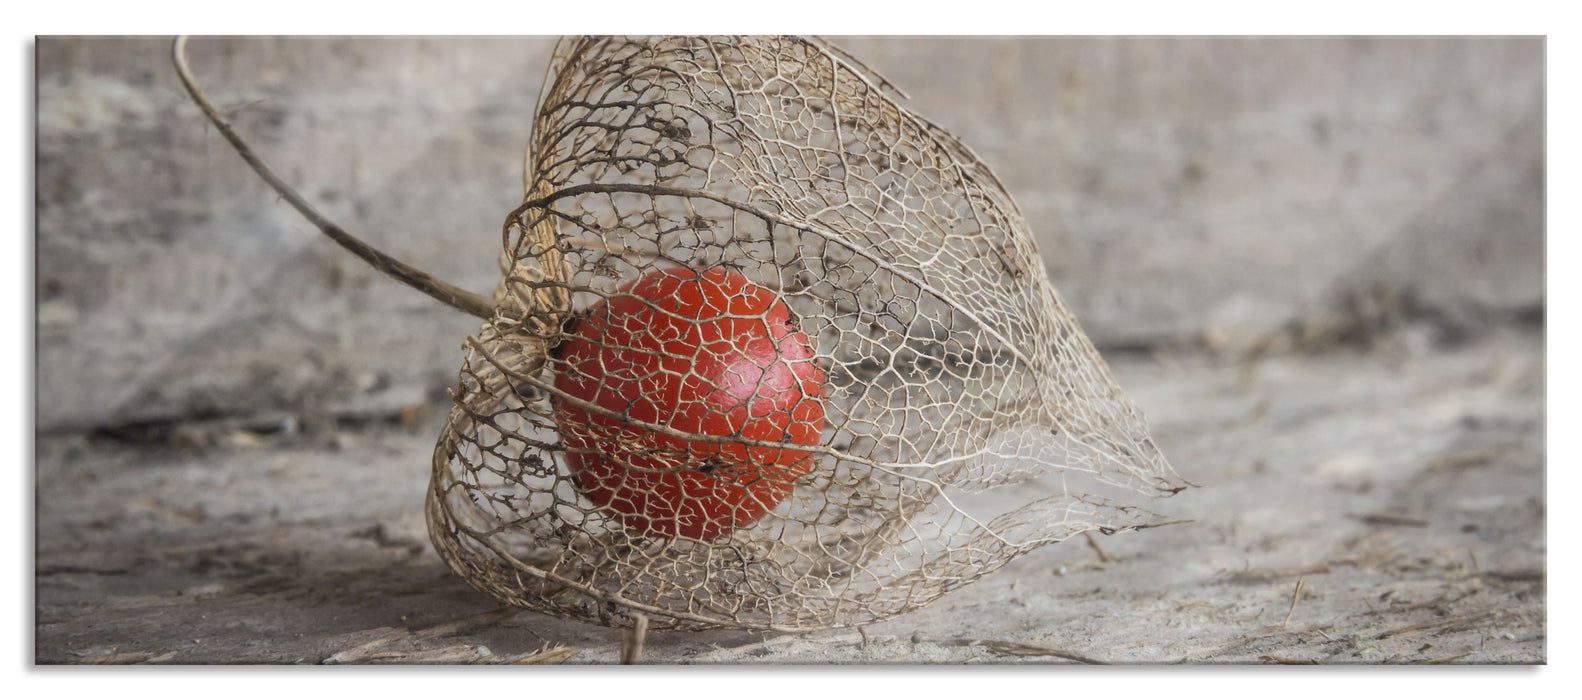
[555,268,824,540]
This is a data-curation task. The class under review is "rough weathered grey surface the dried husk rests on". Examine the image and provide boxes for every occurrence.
[35,319,1547,664]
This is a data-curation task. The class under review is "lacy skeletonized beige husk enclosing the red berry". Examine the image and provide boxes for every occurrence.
[427,38,1182,629]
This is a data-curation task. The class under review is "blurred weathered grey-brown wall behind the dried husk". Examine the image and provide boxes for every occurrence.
[35,38,1544,431]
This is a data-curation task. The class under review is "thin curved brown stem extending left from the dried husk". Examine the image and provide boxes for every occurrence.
[171,36,495,320]
